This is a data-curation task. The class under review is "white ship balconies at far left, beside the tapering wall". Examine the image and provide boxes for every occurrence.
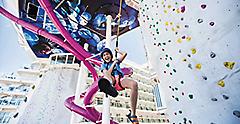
[0,60,42,124]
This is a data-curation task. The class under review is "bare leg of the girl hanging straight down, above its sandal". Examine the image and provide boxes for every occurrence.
[121,78,138,115]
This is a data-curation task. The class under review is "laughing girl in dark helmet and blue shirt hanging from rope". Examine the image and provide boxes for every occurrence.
[100,48,138,124]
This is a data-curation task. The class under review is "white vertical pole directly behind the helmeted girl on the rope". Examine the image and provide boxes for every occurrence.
[102,15,112,124]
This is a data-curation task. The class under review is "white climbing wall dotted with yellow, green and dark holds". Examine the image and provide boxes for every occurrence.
[139,0,240,124]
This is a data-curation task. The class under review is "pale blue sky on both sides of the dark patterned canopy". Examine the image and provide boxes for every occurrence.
[0,0,146,73]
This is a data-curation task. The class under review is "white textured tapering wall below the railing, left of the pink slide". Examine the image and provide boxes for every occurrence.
[18,68,78,124]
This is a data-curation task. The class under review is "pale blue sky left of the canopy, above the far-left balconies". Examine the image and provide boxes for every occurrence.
[0,1,31,73]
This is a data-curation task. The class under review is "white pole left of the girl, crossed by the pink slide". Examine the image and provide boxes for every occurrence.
[71,44,88,124]
